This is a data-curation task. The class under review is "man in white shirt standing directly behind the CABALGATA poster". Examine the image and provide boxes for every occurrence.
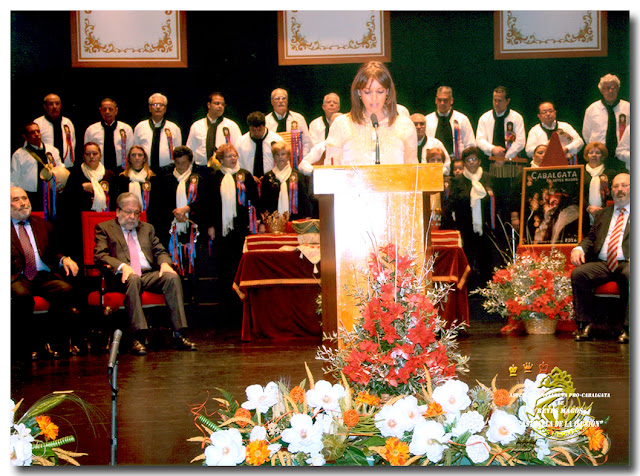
[525,101,584,158]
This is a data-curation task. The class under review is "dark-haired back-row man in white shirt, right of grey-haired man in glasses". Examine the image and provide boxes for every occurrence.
[187,92,242,167]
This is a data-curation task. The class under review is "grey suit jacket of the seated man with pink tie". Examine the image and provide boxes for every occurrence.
[93,219,171,273]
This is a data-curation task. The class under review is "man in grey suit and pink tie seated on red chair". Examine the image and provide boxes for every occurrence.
[94,192,196,355]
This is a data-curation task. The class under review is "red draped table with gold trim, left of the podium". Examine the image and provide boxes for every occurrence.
[233,233,322,341]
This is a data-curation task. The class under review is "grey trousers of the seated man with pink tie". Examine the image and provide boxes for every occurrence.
[111,271,187,332]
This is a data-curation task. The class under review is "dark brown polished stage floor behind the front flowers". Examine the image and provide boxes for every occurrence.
[11,318,630,466]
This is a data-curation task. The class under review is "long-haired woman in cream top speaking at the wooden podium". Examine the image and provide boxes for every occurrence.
[325,61,418,165]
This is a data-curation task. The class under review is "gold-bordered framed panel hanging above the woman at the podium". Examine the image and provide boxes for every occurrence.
[278,10,391,65]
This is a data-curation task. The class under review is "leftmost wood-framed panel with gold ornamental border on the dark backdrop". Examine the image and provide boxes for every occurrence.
[71,10,187,68]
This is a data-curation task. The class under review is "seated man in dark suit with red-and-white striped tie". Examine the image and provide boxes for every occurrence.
[571,173,631,344]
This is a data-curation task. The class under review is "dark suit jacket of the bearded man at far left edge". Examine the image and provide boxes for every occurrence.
[11,216,63,282]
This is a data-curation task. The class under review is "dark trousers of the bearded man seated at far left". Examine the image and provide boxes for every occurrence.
[11,271,72,359]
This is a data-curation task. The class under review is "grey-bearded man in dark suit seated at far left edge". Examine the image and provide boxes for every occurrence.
[10,187,78,362]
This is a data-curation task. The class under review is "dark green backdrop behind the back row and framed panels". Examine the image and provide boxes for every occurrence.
[10,11,630,152]
